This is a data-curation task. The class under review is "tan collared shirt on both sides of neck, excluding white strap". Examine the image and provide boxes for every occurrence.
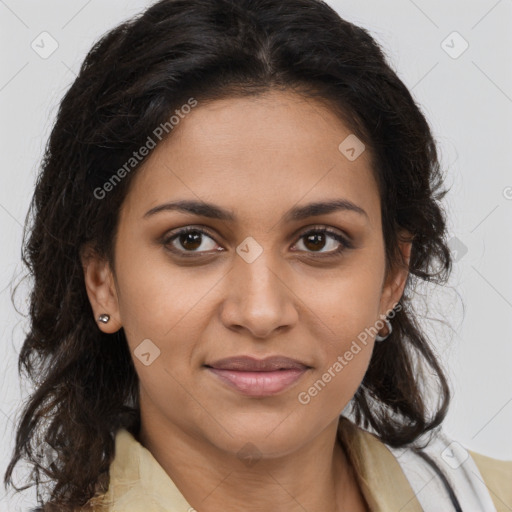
[95,417,512,512]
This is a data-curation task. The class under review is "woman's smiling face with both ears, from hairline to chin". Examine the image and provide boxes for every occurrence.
[86,92,407,456]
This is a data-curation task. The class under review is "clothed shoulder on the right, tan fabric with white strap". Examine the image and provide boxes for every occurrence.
[340,421,512,512]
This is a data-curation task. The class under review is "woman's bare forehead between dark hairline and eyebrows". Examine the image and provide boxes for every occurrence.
[122,91,380,225]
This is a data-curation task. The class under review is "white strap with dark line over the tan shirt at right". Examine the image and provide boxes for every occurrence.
[388,432,496,512]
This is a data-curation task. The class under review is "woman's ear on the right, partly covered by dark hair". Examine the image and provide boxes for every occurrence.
[380,230,414,315]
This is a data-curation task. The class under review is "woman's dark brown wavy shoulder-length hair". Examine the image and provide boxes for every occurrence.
[4,0,452,510]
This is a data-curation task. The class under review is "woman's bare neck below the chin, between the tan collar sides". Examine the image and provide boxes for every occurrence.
[139,416,366,512]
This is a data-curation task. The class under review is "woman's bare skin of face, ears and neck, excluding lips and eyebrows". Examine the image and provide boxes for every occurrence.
[83,91,411,512]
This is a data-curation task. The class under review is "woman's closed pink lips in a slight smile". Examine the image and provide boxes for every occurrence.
[205,356,310,397]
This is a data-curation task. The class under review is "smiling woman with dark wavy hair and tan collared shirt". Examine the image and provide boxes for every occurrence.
[5,0,512,512]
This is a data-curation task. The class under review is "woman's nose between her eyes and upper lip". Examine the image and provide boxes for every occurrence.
[221,251,299,339]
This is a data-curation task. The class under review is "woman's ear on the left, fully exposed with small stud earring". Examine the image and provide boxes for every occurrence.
[80,247,122,334]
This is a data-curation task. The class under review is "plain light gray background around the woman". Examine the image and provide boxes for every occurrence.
[0,0,512,511]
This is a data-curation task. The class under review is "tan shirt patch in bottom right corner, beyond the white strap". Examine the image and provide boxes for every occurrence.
[468,450,512,512]
